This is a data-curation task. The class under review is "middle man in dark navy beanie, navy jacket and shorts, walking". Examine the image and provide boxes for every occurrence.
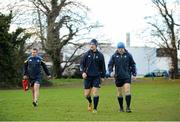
[80,39,106,113]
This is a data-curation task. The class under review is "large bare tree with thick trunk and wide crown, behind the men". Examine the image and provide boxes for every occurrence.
[0,0,105,78]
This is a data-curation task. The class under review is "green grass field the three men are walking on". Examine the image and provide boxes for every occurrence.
[0,79,180,121]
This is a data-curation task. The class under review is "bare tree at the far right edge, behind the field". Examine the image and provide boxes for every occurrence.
[148,0,180,78]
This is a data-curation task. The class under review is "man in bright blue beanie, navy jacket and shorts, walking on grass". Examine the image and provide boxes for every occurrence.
[108,42,136,113]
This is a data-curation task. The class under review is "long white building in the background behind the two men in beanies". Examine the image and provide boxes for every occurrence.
[63,43,170,75]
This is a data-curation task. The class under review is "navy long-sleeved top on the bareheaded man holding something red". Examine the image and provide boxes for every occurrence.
[24,56,50,79]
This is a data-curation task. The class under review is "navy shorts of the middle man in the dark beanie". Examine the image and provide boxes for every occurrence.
[84,77,101,89]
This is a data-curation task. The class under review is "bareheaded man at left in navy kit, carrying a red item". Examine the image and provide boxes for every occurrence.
[23,48,51,107]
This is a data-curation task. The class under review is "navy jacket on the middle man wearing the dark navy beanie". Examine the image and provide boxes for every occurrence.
[80,50,106,77]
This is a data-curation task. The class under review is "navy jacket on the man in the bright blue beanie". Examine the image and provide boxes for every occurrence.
[108,50,136,79]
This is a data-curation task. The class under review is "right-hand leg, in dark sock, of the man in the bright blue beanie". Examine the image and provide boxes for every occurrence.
[124,83,131,112]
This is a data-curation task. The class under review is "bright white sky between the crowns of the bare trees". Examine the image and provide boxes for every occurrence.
[79,0,154,46]
